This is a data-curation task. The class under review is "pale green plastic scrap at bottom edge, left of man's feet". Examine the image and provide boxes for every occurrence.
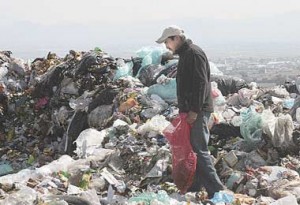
[129,190,170,205]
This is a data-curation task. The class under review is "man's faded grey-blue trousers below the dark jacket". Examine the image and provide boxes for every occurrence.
[190,112,224,198]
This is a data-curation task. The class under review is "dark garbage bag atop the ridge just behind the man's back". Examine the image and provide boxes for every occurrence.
[210,74,249,96]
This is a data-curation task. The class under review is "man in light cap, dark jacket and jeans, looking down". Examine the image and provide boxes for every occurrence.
[156,26,224,198]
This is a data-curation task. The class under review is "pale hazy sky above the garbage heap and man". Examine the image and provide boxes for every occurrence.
[0,0,300,58]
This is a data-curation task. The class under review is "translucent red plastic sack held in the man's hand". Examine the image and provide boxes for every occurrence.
[163,113,197,194]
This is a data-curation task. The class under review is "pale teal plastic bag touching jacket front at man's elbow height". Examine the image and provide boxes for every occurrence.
[147,79,177,102]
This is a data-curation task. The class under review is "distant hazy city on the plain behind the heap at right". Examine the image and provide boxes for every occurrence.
[211,56,300,87]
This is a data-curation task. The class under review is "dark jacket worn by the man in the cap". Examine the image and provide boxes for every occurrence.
[176,40,213,113]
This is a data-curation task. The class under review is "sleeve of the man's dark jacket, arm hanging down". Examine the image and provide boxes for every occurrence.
[190,51,209,113]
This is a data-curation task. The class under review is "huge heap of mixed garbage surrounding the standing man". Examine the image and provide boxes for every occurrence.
[0,47,300,205]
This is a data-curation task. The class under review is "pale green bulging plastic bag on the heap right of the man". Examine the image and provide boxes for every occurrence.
[240,107,262,144]
